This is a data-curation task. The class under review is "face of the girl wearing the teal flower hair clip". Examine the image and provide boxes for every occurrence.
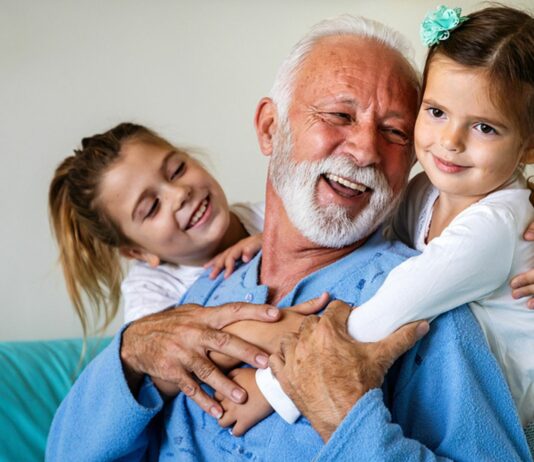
[414,55,524,201]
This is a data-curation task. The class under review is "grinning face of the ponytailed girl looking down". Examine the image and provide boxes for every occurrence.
[99,141,230,266]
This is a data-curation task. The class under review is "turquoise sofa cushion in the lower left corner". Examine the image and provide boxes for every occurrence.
[0,338,110,461]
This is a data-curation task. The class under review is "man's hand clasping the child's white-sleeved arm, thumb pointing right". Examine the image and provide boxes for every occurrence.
[269,301,429,442]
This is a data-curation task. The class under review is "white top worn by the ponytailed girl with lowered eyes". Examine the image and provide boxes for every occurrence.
[121,202,265,322]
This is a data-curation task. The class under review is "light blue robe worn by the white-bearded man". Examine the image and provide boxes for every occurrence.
[47,235,531,462]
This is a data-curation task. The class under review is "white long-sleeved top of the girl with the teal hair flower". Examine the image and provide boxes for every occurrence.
[257,174,534,425]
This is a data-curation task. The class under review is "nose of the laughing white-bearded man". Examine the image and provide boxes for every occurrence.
[344,124,381,167]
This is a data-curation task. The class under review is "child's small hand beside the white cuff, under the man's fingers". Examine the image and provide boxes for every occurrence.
[215,367,273,436]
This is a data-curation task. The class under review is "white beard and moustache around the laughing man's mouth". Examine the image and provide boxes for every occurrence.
[269,121,400,248]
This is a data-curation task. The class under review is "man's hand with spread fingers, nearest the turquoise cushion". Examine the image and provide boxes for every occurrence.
[121,303,280,418]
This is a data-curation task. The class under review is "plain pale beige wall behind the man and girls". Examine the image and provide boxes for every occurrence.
[0,0,532,340]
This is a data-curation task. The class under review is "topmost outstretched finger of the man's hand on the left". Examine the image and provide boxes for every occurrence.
[208,302,280,330]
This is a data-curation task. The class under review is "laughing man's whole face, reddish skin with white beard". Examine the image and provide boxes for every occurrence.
[269,37,417,247]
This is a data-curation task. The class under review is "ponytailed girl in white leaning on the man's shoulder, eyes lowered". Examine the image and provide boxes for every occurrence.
[49,123,263,333]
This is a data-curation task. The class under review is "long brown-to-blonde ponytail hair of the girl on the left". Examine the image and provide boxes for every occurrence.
[48,123,171,337]
